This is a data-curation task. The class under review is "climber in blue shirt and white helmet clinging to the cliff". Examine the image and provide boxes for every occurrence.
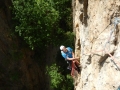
[60,45,80,72]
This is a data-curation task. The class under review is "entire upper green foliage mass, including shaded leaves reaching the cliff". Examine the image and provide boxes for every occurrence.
[13,0,72,49]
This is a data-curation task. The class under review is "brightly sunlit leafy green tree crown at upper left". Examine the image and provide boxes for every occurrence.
[13,0,58,49]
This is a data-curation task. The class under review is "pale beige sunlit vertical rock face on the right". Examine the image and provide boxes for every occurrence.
[72,0,120,90]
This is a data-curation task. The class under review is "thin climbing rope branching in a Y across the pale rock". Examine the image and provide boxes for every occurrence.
[85,17,120,70]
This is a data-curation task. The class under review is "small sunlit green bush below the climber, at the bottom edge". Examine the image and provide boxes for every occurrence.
[47,64,73,90]
